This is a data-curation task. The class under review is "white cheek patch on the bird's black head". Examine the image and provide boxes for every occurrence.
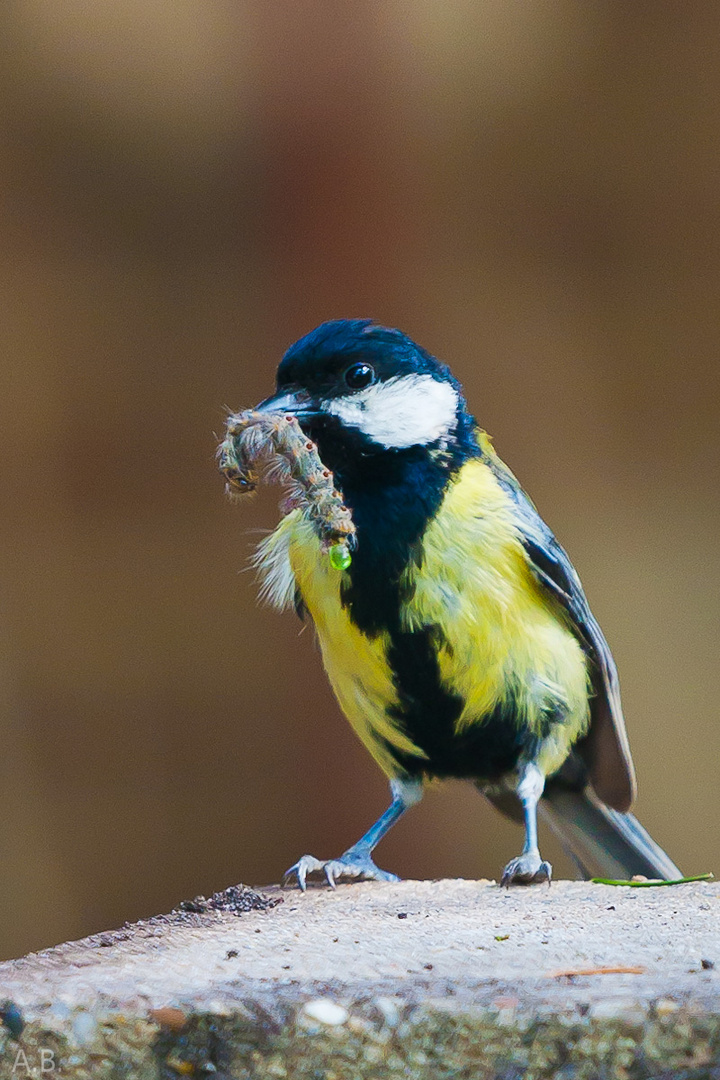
[325,375,458,450]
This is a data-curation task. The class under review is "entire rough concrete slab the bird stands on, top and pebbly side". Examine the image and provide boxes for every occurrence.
[0,880,720,1080]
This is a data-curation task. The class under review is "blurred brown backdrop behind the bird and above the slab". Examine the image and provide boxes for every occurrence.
[0,0,720,956]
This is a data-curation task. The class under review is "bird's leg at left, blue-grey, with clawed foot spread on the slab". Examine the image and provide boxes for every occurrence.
[283,780,422,892]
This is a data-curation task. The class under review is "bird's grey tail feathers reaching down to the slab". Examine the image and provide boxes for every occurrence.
[539,783,682,881]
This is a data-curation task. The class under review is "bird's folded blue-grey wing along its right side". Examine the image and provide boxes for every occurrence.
[480,433,636,813]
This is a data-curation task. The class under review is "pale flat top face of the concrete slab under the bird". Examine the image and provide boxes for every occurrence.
[0,880,720,1009]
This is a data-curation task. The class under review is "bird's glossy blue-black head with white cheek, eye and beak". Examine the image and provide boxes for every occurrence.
[258,319,470,470]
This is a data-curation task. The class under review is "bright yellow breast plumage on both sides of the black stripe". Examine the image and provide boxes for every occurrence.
[259,459,588,775]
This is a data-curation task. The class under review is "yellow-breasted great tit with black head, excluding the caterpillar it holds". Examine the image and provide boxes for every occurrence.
[249,319,681,891]
